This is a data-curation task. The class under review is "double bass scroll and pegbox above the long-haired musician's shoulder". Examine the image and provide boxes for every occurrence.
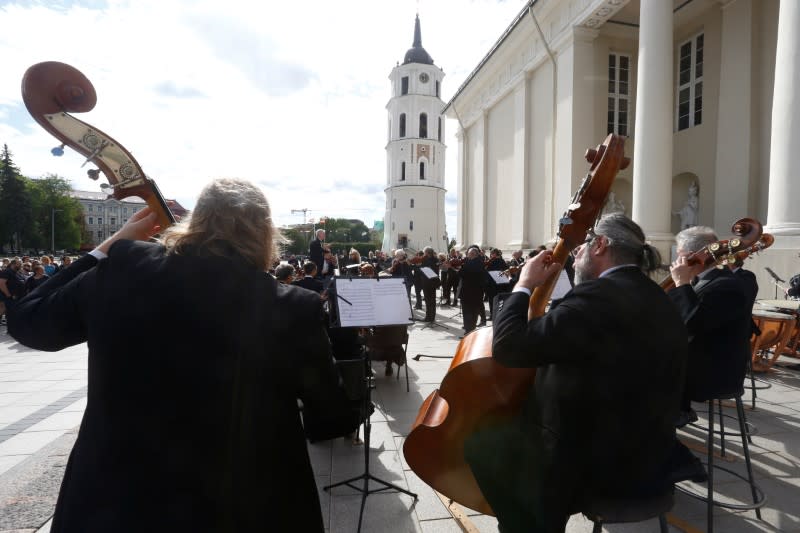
[22,61,175,230]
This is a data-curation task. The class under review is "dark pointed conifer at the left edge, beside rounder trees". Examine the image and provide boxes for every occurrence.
[0,144,33,251]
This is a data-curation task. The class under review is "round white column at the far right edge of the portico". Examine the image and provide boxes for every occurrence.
[766,0,800,235]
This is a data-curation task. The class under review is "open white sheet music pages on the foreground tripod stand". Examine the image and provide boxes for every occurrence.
[335,278,412,328]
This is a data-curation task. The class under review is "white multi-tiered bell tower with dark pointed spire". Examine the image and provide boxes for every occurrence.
[382,15,447,252]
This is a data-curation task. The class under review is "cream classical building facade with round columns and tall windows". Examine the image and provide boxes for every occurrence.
[445,0,800,297]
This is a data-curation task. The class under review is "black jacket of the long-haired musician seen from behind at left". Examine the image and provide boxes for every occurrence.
[8,241,358,532]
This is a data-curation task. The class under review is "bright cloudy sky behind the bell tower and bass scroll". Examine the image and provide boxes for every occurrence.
[0,0,525,235]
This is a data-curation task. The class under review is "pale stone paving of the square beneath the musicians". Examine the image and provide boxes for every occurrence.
[0,300,800,533]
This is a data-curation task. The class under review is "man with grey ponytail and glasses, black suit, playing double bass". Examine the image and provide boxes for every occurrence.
[465,214,687,533]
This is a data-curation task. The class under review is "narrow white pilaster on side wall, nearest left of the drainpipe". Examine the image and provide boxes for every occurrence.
[506,74,530,250]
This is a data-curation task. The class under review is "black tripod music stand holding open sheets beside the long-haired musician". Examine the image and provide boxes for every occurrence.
[322,278,419,533]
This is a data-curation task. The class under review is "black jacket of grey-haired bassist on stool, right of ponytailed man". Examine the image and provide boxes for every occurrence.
[668,268,753,401]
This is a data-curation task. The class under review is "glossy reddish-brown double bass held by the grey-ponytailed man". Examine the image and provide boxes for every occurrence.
[403,134,630,515]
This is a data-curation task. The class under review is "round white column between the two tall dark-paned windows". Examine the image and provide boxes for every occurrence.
[633,0,675,245]
